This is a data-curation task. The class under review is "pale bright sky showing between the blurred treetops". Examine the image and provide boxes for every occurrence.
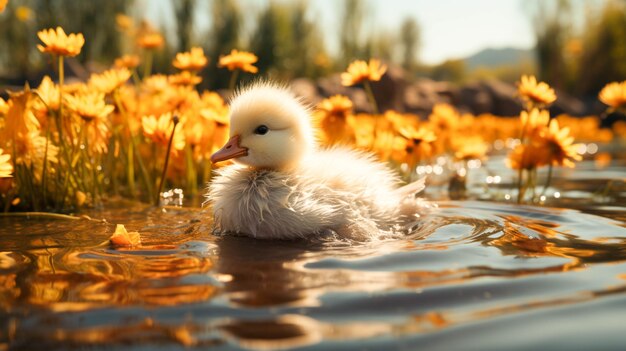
[140,0,604,64]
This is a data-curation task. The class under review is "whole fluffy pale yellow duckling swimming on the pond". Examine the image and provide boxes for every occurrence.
[207,83,424,239]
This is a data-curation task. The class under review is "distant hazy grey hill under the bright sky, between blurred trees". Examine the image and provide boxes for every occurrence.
[464,48,535,71]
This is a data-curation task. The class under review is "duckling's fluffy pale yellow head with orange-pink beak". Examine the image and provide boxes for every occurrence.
[211,83,315,169]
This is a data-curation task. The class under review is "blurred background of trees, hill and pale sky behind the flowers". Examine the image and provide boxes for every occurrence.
[0,0,626,106]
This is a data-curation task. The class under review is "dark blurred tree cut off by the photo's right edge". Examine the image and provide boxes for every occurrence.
[574,1,626,96]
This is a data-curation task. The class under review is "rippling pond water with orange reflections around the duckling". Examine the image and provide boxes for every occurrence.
[0,158,626,350]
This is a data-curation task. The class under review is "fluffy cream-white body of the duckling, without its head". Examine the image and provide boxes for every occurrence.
[207,148,424,240]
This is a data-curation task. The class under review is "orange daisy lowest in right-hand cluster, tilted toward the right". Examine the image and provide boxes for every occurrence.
[534,119,582,167]
